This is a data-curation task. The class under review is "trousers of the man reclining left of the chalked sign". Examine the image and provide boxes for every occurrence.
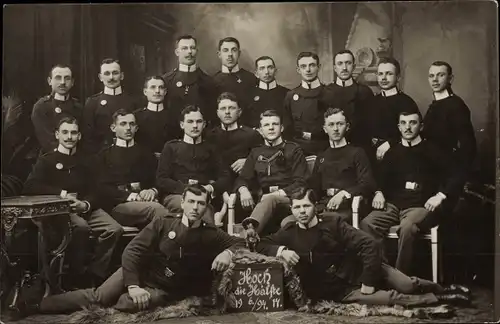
[40,268,174,313]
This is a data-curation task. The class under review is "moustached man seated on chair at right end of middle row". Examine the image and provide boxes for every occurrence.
[360,110,459,274]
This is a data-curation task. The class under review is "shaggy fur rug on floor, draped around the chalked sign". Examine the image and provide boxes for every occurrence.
[64,250,454,324]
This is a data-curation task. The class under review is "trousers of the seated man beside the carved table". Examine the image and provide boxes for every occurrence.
[67,209,123,278]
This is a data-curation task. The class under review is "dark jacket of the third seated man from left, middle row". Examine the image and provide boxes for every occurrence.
[156,140,231,195]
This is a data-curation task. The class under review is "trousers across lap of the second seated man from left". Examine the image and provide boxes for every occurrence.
[111,201,168,229]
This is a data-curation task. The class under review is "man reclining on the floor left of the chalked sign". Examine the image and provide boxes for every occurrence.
[30,185,245,313]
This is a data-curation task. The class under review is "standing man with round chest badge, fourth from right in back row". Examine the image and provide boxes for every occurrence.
[284,52,328,155]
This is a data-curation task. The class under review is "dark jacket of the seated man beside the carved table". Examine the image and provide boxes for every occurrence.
[24,149,99,214]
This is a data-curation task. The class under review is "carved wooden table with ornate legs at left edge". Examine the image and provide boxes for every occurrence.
[1,195,71,311]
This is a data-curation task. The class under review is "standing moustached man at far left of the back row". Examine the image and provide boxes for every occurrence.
[31,64,82,153]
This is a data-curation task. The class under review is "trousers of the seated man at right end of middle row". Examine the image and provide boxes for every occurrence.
[360,203,435,274]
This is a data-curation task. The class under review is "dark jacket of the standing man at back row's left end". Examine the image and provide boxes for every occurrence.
[31,95,83,153]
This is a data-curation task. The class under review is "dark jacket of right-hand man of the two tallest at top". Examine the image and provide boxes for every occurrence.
[213,68,257,111]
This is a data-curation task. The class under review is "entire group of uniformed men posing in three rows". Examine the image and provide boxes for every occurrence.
[24,35,476,311]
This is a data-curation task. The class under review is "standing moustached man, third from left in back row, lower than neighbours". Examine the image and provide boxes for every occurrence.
[135,76,174,153]
